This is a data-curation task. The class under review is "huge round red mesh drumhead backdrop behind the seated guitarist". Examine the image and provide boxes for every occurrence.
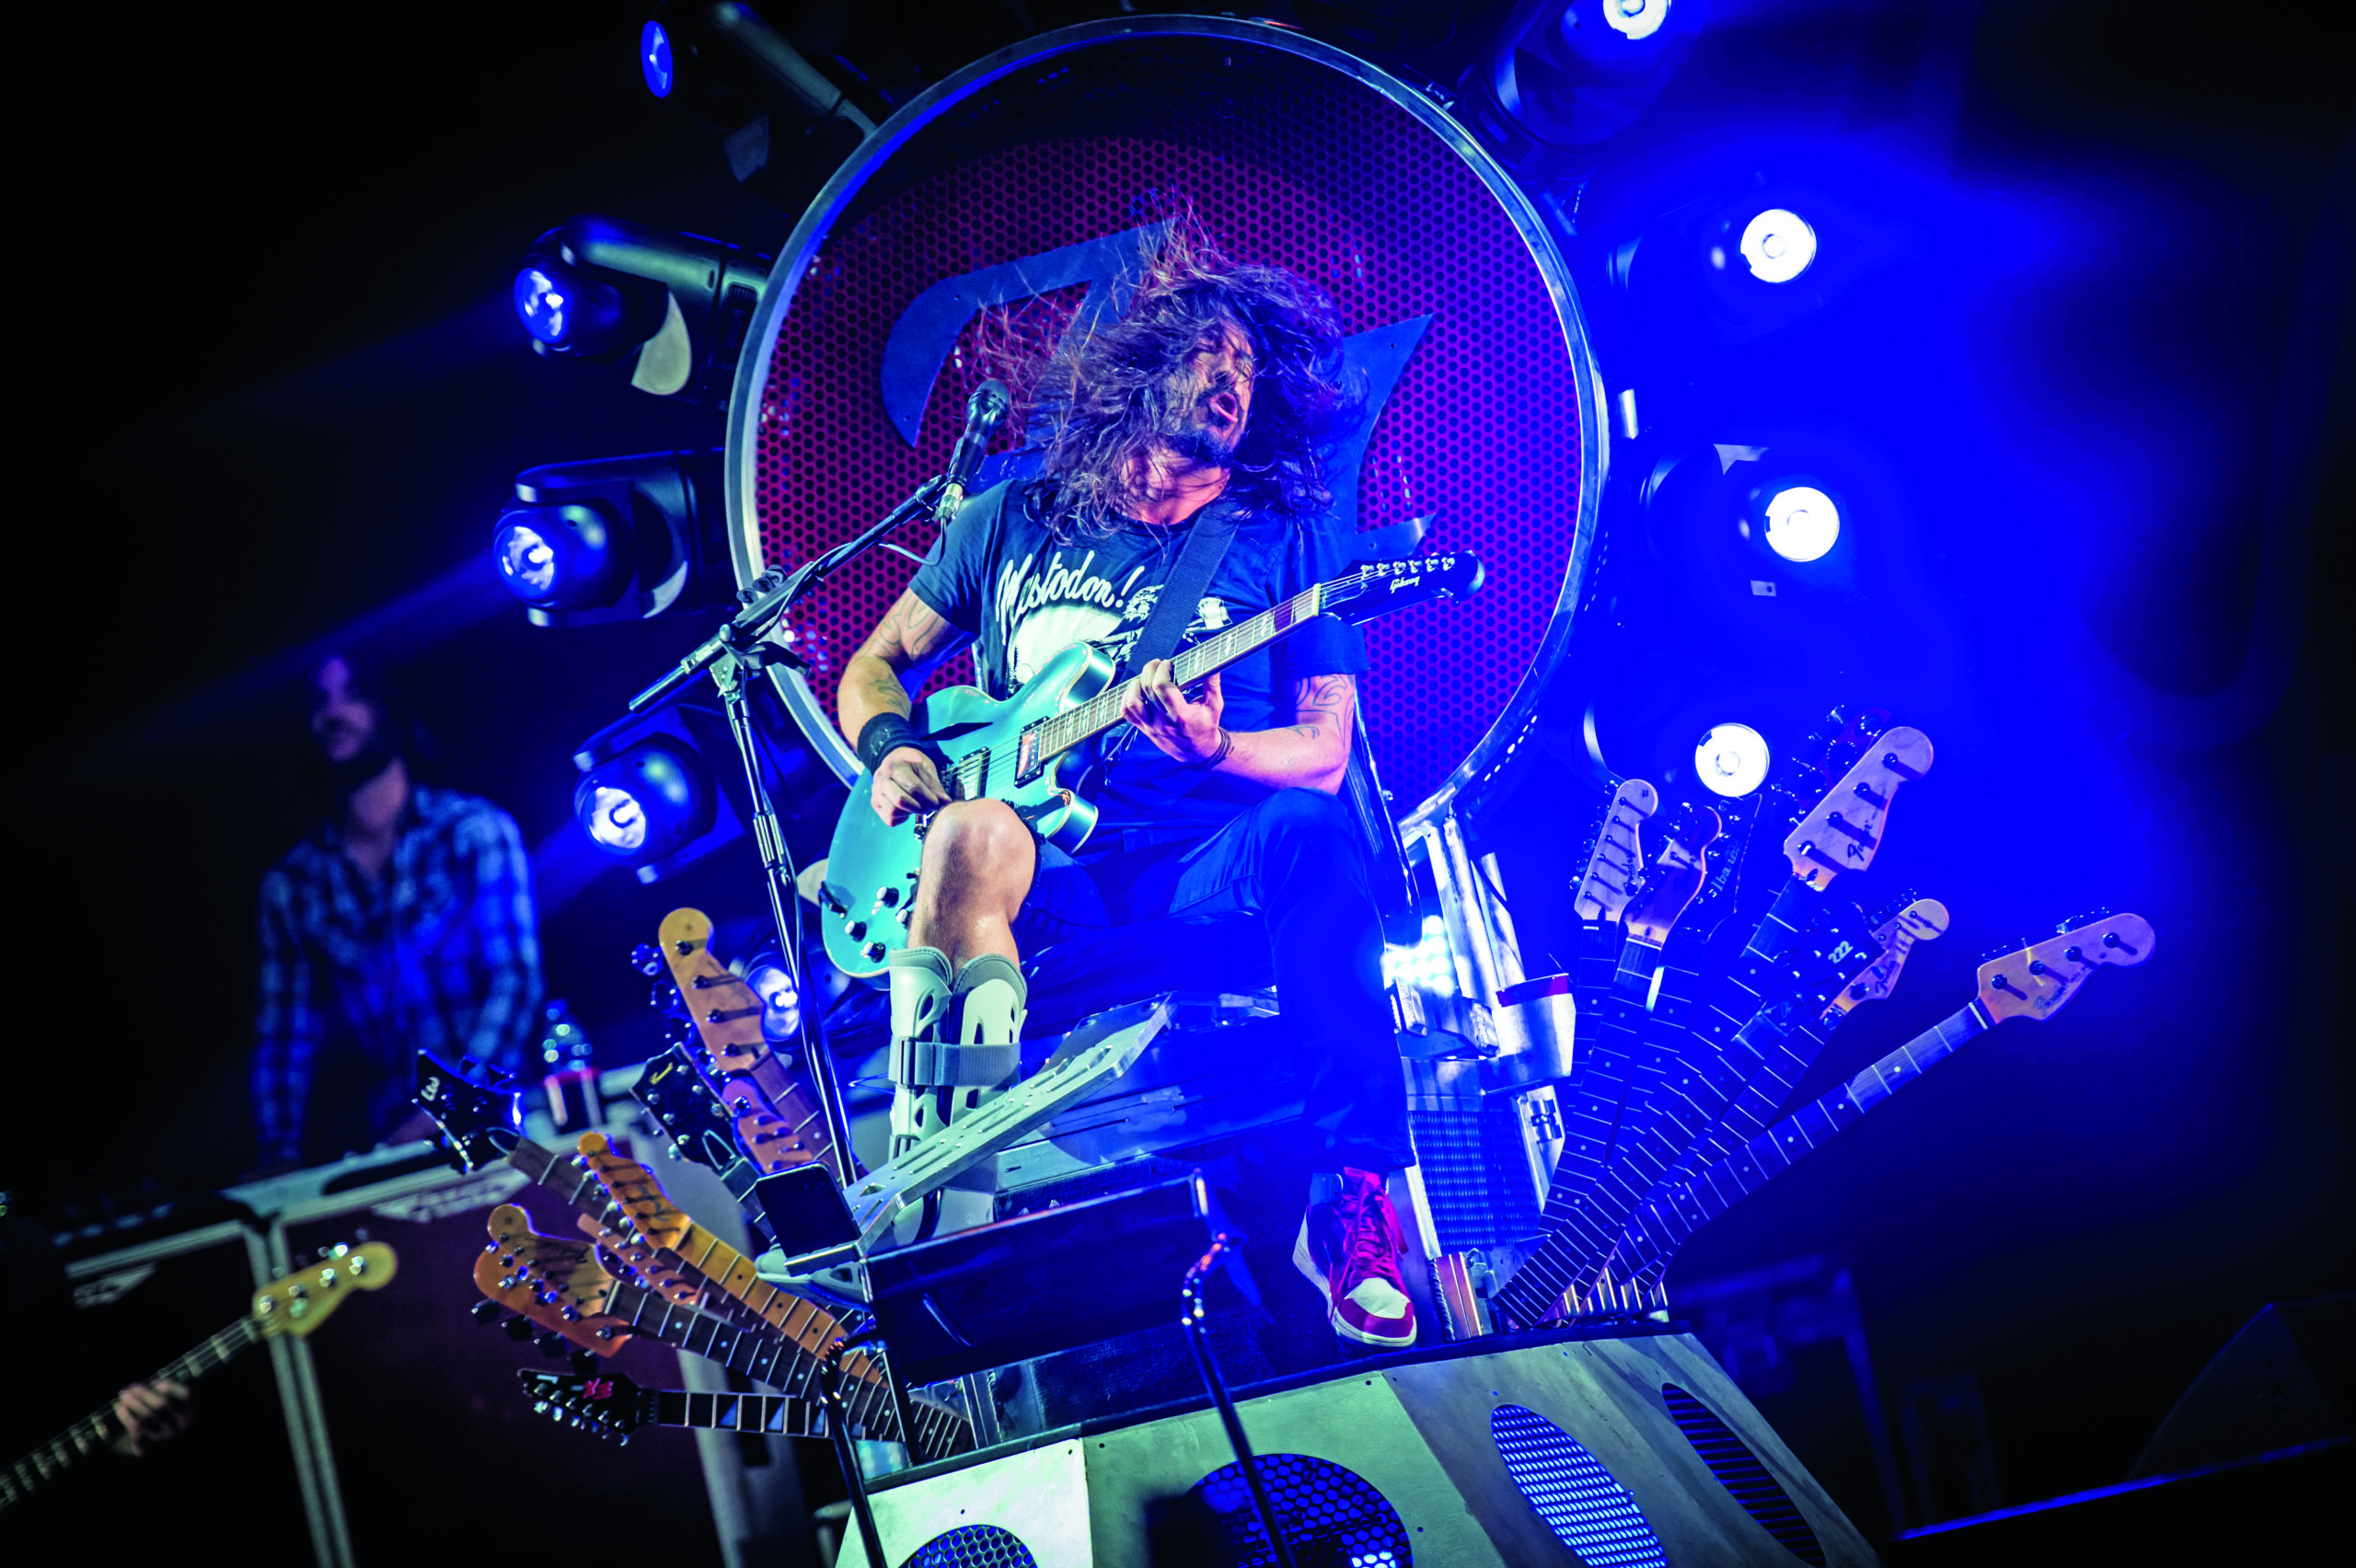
[728,18,1604,817]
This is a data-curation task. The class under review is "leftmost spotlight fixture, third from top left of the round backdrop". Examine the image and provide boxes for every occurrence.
[490,452,728,627]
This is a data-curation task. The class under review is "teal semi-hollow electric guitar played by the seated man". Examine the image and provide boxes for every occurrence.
[817,551,1486,977]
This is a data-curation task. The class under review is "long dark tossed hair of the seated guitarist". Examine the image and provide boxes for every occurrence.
[1025,212,1359,532]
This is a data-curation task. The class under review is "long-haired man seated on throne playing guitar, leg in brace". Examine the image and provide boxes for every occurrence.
[837,228,1416,1346]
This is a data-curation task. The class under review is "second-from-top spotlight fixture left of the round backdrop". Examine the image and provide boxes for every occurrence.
[514,212,770,403]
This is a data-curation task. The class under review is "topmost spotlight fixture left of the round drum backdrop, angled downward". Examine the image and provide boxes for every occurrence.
[639,0,874,212]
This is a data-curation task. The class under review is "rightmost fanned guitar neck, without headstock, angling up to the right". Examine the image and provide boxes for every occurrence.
[1614,1000,1989,1281]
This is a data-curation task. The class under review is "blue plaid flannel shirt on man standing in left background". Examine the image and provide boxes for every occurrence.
[252,789,539,1159]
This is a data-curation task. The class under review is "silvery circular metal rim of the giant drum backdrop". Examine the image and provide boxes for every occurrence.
[723,17,1609,829]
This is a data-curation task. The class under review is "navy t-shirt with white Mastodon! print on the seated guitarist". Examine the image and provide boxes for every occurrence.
[909,480,1367,850]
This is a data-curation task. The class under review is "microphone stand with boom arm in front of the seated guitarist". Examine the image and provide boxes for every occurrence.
[629,476,950,1192]
